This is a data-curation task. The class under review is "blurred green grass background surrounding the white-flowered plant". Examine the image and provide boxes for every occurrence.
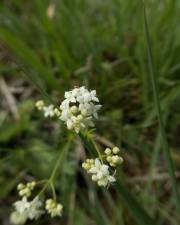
[0,0,180,225]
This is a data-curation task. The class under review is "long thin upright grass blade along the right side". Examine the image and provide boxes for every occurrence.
[142,1,180,211]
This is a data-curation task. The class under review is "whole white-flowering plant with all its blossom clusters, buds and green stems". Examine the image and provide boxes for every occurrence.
[10,86,123,224]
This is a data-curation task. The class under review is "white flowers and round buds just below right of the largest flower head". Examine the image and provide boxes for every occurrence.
[82,147,123,187]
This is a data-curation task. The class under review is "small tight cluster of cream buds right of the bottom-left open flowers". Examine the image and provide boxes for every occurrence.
[46,198,63,217]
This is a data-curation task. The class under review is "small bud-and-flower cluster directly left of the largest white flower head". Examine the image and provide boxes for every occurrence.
[36,100,60,117]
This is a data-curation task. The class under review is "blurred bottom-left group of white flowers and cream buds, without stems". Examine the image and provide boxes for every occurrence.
[10,181,63,225]
